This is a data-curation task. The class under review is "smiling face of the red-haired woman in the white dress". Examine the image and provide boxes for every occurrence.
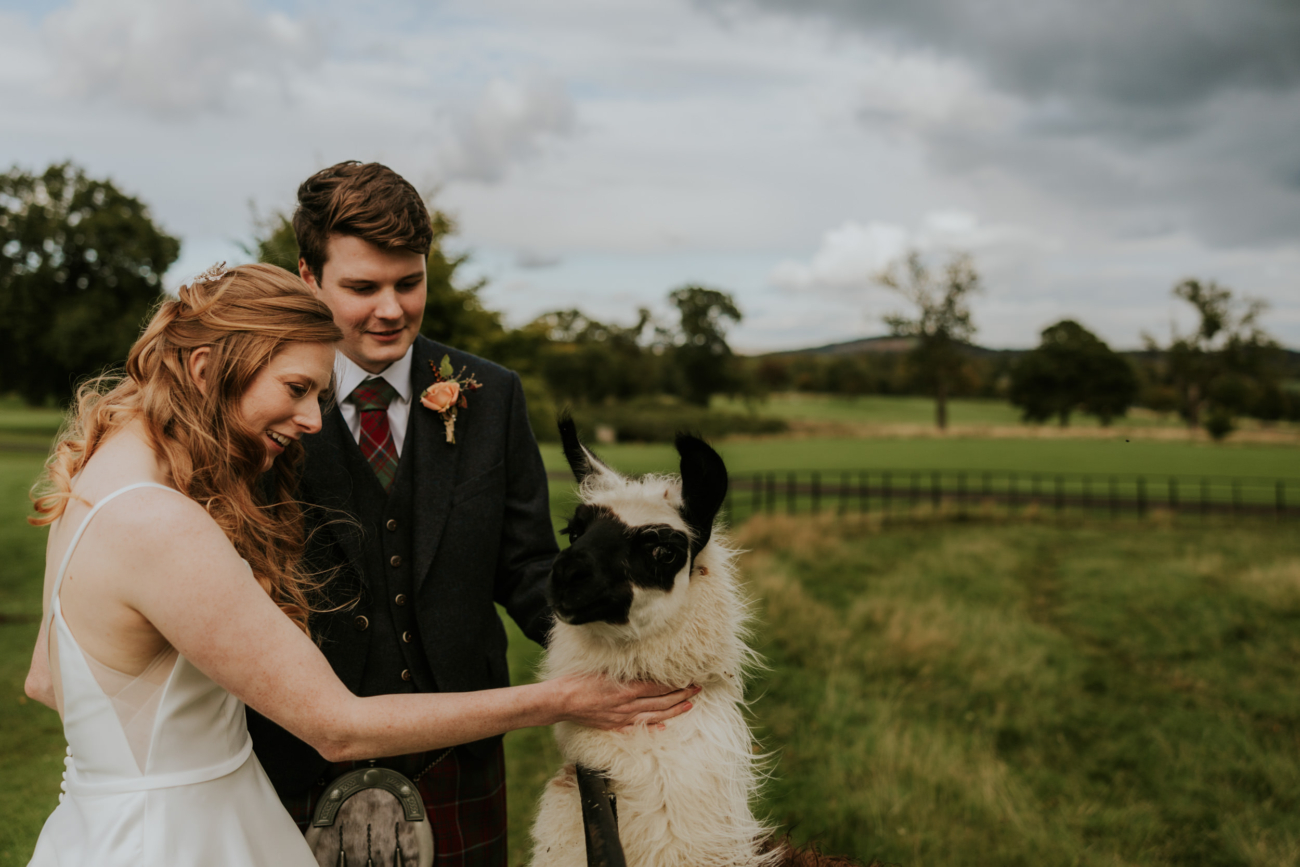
[239,343,334,471]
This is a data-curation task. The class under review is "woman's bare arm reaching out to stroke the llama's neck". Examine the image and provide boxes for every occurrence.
[100,491,694,760]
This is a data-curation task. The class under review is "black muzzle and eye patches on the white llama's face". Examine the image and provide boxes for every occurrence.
[550,504,690,625]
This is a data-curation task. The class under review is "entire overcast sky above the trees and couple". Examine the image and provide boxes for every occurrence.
[0,0,1300,351]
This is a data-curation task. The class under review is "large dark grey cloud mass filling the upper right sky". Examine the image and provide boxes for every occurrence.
[697,0,1300,244]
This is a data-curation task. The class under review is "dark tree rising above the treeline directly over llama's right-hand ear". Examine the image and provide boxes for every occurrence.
[666,285,741,407]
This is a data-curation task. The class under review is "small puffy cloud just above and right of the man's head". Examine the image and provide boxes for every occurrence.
[434,77,576,182]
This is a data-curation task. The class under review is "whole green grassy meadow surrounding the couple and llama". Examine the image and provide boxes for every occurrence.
[0,402,1300,867]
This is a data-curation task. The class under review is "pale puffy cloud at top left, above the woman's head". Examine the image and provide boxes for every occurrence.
[44,0,321,118]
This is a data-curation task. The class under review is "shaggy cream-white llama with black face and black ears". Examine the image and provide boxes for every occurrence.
[532,417,852,867]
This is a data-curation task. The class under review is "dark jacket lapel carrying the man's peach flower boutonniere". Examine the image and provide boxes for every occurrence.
[413,337,460,593]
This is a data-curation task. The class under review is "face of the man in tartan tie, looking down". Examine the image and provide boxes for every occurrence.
[298,235,428,373]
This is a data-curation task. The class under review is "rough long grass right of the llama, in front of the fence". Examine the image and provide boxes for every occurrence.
[742,520,1300,867]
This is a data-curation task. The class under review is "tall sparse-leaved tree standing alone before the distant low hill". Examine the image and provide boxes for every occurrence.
[876,250,982,430]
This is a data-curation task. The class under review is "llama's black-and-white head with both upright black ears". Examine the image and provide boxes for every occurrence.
[549,419,727,630]
